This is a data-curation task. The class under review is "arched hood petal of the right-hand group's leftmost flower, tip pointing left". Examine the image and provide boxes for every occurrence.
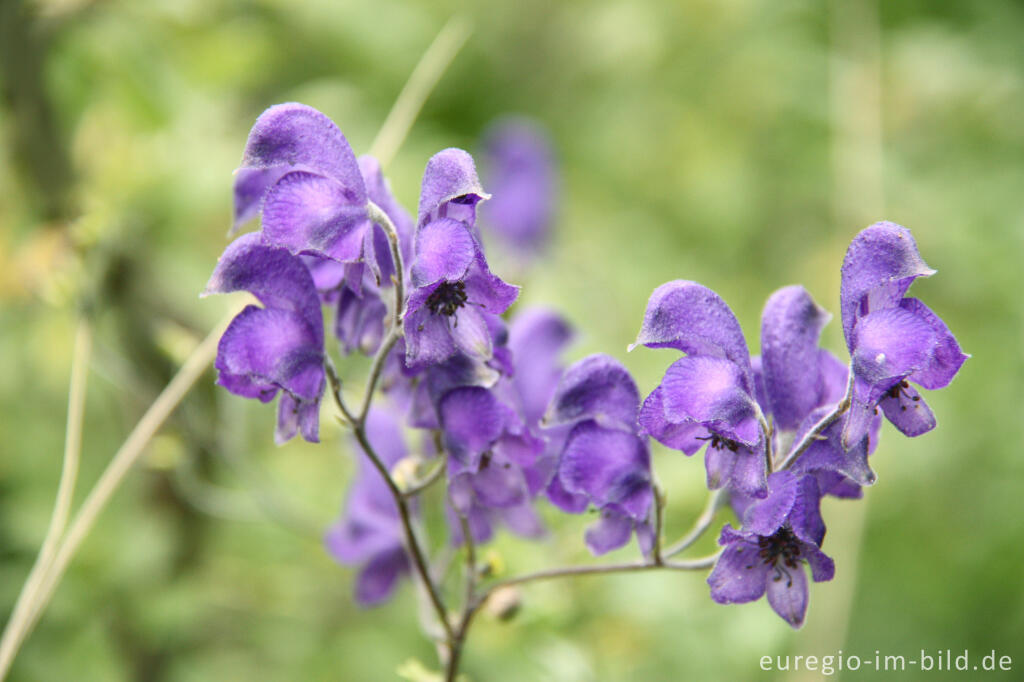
[631,280,751,377]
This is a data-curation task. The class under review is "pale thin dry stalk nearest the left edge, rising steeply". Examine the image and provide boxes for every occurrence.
[0,316,92,680]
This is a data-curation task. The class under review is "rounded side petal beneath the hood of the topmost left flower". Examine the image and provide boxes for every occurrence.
[263,171,371,262]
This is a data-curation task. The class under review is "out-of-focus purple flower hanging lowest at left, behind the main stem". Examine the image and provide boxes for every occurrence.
[324,409,410,606]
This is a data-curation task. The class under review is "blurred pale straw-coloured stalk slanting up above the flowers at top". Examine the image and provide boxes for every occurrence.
[370,16,472,168]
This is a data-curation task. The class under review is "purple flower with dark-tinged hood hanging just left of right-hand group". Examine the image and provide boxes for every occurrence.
[542,354,654,555]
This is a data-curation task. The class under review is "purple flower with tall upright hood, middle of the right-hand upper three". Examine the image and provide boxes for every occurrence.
[761,285,878,497]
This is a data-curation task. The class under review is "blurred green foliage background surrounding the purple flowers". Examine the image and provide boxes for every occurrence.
[0,0,1024,682]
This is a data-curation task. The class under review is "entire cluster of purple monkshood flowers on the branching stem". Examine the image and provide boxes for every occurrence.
[207,103,967,630]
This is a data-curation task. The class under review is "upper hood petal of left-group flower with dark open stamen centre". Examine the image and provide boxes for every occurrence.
[417,147,490,228]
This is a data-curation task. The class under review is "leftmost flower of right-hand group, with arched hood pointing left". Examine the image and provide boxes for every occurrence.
[630,280,767,497]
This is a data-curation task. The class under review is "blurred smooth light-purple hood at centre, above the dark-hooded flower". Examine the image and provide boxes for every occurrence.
[508,308,572,424]
